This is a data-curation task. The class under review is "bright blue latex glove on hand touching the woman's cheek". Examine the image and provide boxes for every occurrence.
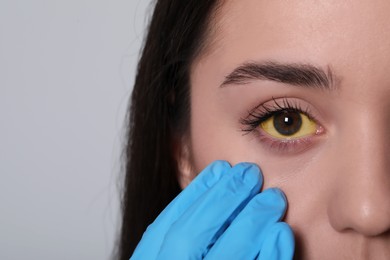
[130,161,294,260]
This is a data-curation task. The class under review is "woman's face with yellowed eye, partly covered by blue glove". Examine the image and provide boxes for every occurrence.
[185,0,390,259]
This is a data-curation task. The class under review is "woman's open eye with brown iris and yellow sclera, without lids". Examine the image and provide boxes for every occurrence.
[260,110,318,139]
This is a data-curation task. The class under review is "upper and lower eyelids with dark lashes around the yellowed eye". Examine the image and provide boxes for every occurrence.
[240,98,323,153]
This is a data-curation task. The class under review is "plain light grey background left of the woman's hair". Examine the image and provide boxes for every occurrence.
[0,0,151,260]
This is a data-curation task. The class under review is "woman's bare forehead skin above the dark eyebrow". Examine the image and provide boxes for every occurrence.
[191,0,390,98]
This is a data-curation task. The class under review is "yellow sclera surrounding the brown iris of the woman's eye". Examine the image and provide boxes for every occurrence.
[260,112,318,140]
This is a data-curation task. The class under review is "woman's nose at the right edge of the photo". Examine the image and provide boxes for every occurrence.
[327,116,390,237]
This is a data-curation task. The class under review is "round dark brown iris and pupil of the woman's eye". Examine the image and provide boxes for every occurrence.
[274,111,302,136]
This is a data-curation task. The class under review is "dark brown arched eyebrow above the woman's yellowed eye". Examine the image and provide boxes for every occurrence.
[220,62,336,90]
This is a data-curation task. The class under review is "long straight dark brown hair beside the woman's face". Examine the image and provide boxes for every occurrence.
[115,0,220,260]
